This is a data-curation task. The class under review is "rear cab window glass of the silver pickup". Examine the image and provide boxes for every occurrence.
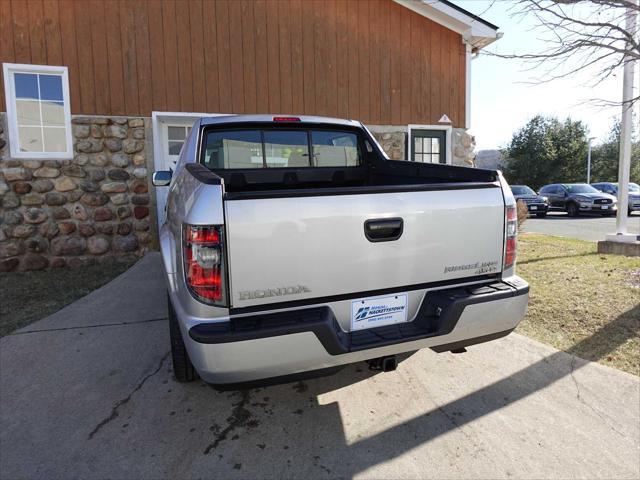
[202,129,361,170]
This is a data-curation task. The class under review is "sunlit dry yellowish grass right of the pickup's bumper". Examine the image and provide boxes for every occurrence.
[517,234,640,375]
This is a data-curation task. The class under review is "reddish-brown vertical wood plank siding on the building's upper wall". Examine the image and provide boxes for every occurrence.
[0,0,466,127]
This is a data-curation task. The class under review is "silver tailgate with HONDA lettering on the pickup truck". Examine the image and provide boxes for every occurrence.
[225,184,504,308]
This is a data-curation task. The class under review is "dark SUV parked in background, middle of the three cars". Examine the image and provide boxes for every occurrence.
[538,183,617,217]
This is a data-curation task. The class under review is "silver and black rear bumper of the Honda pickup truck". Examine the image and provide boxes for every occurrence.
[184,276,529,384]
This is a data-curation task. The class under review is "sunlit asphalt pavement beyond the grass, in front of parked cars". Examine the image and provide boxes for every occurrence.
[523,212,640,242]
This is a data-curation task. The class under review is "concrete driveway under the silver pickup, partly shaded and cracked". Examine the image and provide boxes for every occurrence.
[0,254,640,479]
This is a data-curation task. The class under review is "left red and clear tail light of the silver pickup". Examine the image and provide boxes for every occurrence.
[184,225,225,306]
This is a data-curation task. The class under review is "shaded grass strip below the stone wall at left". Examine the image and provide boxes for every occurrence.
[0,263,132,337]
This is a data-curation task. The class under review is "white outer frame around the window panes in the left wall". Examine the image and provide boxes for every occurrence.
[2,63,73,160]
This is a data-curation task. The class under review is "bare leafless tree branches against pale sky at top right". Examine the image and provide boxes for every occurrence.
[487,0,640,103]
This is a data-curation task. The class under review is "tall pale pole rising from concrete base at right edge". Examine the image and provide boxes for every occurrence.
[607,0,638,243]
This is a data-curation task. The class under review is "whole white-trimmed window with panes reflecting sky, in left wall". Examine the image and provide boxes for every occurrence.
[2,63,73,159]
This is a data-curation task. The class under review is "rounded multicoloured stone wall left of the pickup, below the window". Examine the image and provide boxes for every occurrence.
[0,114,156,272]
